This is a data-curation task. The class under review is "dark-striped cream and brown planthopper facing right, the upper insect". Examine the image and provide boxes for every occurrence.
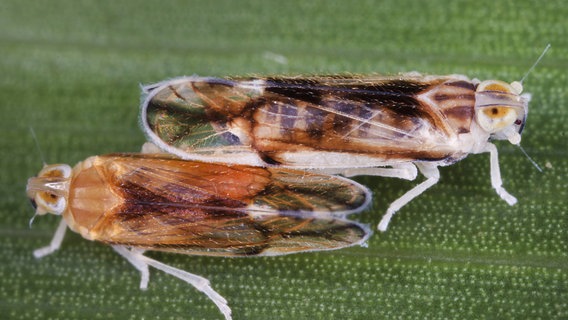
[140,73,530,231]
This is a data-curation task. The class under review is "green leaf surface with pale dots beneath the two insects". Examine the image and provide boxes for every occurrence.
[0,0,568,319]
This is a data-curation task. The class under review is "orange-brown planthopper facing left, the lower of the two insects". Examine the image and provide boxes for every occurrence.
[27,154,371,319]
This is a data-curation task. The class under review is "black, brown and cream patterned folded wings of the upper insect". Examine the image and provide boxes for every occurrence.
[142,77,474,167]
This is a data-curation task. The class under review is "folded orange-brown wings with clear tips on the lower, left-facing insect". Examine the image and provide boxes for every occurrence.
[75,155,370,256]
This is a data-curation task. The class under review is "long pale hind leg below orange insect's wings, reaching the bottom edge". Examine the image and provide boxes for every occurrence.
[113,246,232,320]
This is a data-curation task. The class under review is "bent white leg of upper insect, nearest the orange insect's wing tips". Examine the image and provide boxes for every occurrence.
[379,163,440,231]
